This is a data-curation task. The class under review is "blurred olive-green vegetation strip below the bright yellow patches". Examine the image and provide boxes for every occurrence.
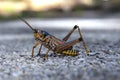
[0,7,82,20]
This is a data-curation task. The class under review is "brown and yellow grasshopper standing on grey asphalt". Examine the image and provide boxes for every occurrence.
[20,18,89,60]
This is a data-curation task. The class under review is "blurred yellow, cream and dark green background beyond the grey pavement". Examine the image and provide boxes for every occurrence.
[0,0,120,17]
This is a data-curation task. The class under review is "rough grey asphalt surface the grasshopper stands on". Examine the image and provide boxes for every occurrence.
[0,19,120,80]
